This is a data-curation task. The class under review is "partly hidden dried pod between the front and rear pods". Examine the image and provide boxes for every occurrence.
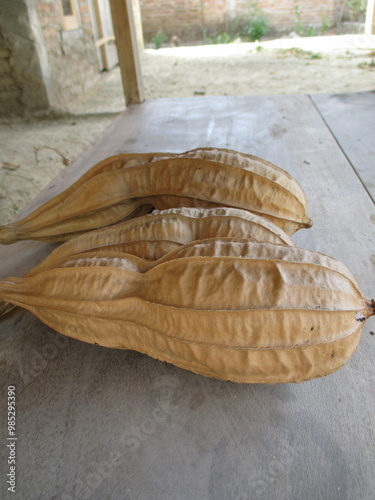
[27,208,293,276]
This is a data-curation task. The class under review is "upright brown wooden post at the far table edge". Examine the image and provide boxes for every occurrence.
[109,0,145,106]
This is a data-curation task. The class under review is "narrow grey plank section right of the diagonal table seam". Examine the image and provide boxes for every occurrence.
[312,92,375,201]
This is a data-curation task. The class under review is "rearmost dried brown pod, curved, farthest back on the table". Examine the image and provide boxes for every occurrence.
[0,149,311,244]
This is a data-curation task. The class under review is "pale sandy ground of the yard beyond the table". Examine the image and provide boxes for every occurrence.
[0,35,375,224]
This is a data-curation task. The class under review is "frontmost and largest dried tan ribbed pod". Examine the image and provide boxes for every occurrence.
[0,242,375,383]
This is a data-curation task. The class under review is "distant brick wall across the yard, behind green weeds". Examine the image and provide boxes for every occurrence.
[140,0,342,42]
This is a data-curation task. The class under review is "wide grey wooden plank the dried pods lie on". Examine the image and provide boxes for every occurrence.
[0,96,375,500]
